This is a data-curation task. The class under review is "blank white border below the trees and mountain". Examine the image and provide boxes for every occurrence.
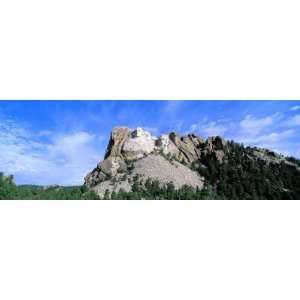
[0,201,300,300]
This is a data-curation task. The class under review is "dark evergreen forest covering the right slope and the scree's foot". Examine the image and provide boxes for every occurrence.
[109,142,300,200]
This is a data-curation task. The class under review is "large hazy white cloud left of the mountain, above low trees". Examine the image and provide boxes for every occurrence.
[0,121,102,185]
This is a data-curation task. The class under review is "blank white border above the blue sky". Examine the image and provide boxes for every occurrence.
[0,0,300,99]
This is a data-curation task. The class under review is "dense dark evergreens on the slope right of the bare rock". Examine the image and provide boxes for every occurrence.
[197,142,300,199]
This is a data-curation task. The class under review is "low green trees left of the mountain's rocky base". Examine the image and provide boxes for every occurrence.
[0,173,99,200]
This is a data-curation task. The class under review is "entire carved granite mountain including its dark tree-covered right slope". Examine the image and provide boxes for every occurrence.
[84,127,300,199]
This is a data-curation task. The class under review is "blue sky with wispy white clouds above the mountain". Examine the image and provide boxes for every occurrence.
[0,101,300,185]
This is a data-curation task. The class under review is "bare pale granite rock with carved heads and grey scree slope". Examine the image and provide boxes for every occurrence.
[85,127,227,195]
